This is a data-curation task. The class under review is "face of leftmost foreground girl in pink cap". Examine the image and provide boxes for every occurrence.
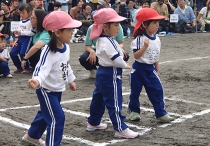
[56,28,72,43]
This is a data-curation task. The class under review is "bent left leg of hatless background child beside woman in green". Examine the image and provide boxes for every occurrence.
[10,42,21,69]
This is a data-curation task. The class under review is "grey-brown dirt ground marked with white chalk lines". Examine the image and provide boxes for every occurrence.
[0,33,210,146]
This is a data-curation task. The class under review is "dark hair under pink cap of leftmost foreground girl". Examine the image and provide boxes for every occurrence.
[48,28,66,53]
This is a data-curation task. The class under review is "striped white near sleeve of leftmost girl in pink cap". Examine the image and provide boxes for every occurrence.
[33,45,53,85]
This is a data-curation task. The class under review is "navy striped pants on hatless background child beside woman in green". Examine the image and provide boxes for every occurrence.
[10,36,32,69]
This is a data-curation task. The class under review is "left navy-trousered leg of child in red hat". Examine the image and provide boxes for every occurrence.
[128,62,143,114]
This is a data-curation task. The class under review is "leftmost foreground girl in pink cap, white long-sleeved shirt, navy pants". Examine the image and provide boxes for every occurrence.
[22,11,82,146]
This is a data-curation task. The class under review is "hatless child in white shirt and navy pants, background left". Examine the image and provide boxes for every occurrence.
[10,3,34,73]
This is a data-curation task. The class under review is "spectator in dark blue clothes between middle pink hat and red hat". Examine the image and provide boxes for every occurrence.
[112,0,132,36]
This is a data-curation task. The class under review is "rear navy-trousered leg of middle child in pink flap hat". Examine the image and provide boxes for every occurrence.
[88,88,105,126]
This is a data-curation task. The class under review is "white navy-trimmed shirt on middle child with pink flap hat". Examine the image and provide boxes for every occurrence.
[96,36,127,68]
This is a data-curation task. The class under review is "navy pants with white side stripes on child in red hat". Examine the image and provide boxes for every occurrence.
[128,61,167,118]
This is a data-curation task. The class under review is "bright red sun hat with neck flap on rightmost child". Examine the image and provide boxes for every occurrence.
[133,8,165,34]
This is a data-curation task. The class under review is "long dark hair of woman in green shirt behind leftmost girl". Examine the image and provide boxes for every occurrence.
[34,9,47,32]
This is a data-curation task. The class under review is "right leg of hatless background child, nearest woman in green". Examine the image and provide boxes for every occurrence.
[20,37,32,70]
